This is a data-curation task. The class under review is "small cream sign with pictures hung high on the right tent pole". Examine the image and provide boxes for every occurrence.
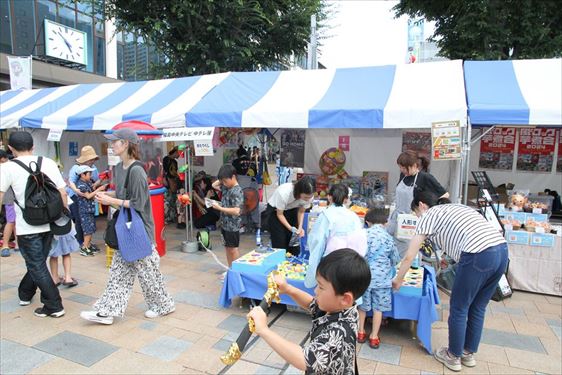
[431,120,461,160]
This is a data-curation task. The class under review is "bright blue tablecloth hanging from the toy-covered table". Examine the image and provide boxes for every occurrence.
[219,266,440,354]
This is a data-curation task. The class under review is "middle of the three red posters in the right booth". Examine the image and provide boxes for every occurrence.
[517,128,556,172]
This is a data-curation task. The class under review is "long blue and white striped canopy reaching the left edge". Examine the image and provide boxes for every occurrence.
[0,61,467,130]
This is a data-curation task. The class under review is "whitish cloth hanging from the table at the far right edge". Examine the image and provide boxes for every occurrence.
[507,236,562,296]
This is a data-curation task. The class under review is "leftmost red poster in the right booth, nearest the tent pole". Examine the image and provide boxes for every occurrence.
[478,128,515,171]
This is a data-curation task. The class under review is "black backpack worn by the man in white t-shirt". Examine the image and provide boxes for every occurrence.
[12,156,64,225]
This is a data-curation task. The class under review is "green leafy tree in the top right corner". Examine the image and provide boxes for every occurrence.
[394,0,562,60]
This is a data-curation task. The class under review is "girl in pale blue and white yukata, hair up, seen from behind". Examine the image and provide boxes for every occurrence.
[304,184,367,288]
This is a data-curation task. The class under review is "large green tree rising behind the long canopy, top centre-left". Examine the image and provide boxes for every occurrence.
[96,0,329,77]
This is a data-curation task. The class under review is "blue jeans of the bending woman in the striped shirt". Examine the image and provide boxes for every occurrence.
[449,243,508,357]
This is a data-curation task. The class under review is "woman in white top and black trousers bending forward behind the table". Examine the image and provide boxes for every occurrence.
[267,176,316,256]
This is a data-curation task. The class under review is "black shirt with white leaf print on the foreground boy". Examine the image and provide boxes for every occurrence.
[303,299,359,375]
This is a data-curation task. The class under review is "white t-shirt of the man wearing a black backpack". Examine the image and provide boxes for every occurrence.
[0,155,66,236]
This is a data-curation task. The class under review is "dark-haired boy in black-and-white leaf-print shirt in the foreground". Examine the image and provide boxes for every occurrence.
[248,249,371,375]
